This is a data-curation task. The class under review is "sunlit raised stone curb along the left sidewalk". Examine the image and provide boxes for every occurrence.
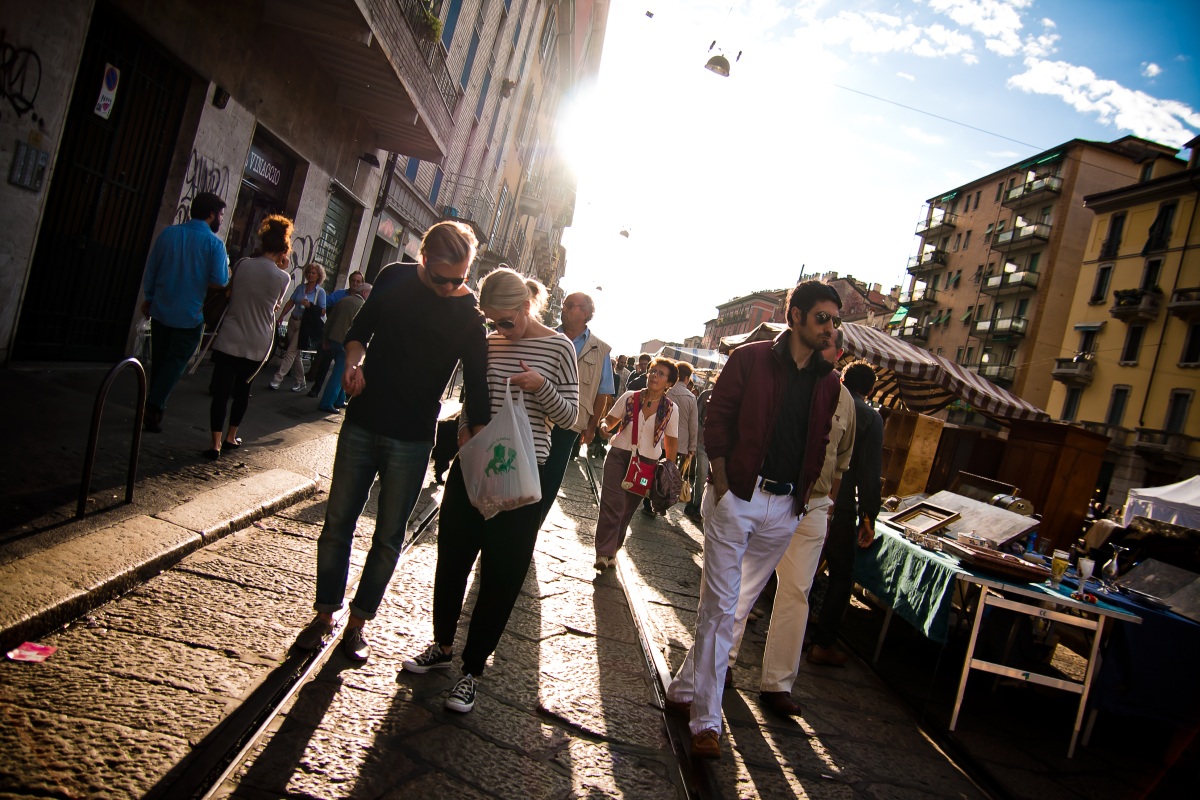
[0,469,319,652]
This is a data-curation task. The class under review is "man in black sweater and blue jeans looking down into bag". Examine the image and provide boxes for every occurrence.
[296,222,491,661]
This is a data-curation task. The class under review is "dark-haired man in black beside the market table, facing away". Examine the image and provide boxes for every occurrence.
[808,361,883,667]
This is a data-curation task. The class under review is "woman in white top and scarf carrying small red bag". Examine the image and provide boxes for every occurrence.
[595,359,679,571]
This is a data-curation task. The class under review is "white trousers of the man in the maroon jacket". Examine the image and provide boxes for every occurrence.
[667,489,797,735]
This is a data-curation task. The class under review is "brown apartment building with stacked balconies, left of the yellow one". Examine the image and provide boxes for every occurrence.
[893,137,1182,408]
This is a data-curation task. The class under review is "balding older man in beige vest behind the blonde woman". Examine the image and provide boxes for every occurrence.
[541,291,616,522]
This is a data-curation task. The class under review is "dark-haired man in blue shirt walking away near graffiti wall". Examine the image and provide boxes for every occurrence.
[142,192,229,433]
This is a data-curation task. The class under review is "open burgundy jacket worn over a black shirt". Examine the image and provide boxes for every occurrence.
[704,331,841,515]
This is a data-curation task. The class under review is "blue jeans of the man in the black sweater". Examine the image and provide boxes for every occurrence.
[313,422,433,619]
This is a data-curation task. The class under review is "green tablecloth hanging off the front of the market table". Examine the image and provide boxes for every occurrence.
[854,522,968,642]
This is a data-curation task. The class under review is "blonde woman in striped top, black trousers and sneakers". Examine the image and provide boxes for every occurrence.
[404,269,580,712]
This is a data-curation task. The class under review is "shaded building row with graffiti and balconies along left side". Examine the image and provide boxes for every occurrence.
[0,0,606,363]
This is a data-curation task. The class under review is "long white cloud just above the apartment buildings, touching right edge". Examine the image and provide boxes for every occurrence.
[1008,58,1200,146]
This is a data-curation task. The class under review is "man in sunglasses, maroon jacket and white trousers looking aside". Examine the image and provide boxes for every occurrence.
[667,281,841,758]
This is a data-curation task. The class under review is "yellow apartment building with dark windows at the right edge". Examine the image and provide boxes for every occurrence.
[1048,138,1200,505]
